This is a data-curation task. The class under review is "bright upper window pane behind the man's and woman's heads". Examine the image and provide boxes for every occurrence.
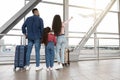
[26,3,63,27]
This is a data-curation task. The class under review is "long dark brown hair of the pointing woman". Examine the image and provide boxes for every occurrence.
[52,15,62,36]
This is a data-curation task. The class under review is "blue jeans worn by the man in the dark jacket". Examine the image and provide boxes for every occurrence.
[26,39,41,67]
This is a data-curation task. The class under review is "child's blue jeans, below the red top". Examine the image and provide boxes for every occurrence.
[45,42,55,68]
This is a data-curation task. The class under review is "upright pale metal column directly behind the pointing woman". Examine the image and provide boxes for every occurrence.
[63,0,69,47]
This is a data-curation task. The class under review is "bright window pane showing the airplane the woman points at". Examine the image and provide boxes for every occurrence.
[69,7,94,32]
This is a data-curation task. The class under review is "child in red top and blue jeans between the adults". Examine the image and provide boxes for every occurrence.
[42,27,56,71]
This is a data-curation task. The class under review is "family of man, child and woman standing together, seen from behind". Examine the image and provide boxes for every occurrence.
[22,8,72,71]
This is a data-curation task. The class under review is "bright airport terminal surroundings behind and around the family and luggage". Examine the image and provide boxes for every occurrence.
[0,0,120,80]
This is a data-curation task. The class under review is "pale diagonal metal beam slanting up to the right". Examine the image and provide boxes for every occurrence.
[74,0,116,52]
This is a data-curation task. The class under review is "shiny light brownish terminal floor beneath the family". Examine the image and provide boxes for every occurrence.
[0,59,120,80]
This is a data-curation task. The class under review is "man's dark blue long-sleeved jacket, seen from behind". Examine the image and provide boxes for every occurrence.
[22,15,44,40]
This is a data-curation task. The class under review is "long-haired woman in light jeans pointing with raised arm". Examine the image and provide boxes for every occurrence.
[52,15,72,68]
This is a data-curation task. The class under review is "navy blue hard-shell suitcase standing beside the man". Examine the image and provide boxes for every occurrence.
[14,45,27,70]
